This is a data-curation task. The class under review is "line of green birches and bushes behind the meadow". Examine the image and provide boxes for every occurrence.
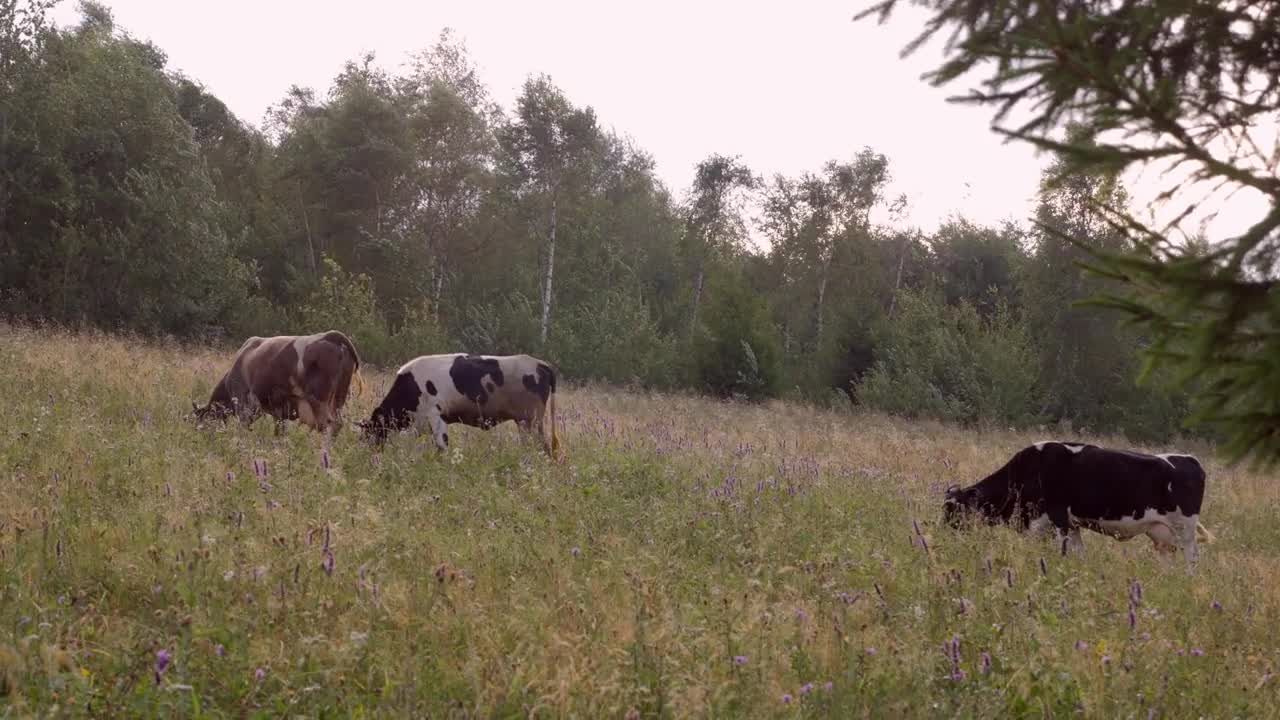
[0,0,1188,438]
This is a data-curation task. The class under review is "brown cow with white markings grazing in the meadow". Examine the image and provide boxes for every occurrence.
[191,331,364,441]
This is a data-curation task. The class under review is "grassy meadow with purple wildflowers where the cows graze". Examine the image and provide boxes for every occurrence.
[0,327,1280,717]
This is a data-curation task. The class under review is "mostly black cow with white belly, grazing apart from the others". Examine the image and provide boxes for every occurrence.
[943,441,1213,564]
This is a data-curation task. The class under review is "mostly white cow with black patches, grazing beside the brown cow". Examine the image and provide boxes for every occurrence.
[360,352,559,460]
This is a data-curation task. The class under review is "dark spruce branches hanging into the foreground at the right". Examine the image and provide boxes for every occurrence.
[859,0,1280,465]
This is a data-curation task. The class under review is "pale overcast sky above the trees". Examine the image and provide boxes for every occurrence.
[55,0,1265,242]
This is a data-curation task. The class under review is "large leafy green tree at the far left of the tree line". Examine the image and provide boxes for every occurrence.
[0,3,248,336]
